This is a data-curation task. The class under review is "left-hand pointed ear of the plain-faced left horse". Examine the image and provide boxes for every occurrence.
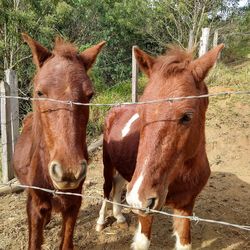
[22,33,52,69]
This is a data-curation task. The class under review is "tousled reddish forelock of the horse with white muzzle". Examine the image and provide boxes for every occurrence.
[155,45,193,77]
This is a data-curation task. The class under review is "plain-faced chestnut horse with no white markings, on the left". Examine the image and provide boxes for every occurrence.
[13,34,105,250]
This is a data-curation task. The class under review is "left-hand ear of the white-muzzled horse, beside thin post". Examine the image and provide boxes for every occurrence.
[134,48,155,77]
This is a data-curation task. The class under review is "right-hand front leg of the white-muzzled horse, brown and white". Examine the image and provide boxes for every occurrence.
[173,204,193,250]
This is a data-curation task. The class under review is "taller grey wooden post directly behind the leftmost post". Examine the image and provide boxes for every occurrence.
[5,69,19,153]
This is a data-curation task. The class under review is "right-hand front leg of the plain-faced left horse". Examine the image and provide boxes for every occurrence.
[59,197,82,250]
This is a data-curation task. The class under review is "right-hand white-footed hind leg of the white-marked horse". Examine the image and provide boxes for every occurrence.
[113,173,126,225]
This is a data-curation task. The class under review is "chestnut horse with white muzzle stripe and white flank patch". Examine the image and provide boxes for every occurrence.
[96,45,224,250]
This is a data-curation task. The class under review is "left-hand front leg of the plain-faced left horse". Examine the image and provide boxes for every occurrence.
[27,194,51,250]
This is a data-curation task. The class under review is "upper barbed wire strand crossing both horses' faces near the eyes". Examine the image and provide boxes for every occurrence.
[0,90,250,107]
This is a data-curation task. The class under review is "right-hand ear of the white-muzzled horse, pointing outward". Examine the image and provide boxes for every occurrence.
[190,44,224,82]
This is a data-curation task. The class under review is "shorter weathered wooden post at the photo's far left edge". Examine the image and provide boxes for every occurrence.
[0,81,14,183]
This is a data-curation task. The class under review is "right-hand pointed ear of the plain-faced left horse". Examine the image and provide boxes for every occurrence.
[81,41,106,71]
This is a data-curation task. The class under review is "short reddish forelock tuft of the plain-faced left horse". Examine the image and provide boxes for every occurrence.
[52,37,78,60]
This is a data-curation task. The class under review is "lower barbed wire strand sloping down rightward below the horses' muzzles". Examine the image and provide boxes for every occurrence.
[0,182,250,231]
